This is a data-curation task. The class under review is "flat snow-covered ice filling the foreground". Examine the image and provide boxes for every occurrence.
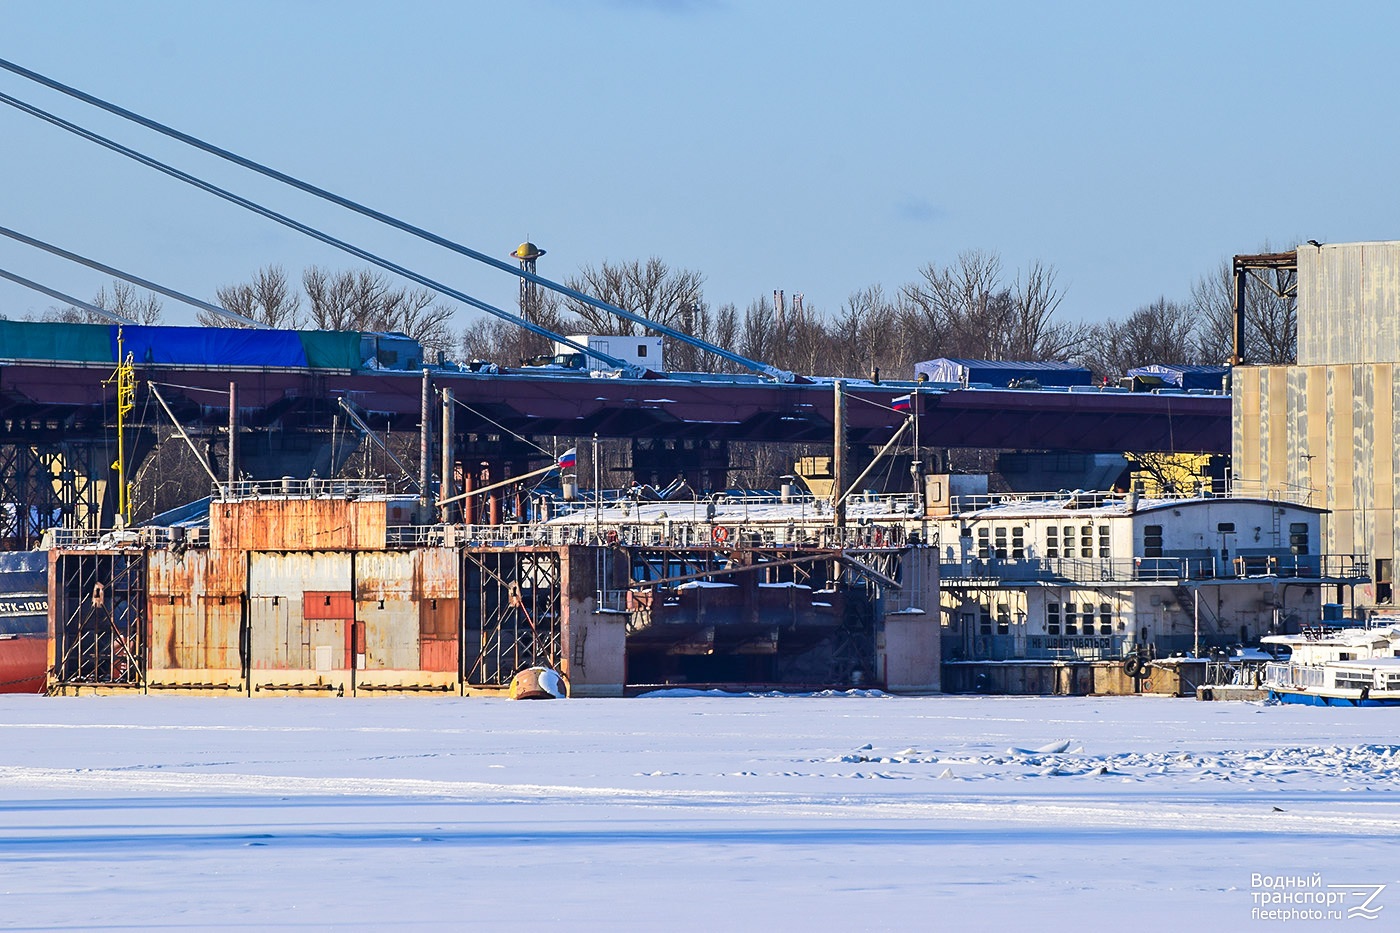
[0,691,1400,930]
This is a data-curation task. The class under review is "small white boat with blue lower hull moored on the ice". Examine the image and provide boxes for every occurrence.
[1260,623,1400,706]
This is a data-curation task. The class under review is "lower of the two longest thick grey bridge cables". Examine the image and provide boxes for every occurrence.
[0,94,636,370]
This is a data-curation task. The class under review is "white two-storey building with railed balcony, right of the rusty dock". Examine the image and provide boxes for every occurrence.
[937,492,1365,661]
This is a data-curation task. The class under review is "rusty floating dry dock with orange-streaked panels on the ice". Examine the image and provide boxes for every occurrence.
[48,481,939,696]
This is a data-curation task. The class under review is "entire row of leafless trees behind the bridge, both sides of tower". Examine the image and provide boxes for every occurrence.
[21,244,1298,380]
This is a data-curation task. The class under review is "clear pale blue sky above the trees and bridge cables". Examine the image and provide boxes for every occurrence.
[0,0,1400,334]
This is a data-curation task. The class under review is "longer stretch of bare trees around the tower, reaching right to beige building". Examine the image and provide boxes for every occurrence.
[461,247,1298,380]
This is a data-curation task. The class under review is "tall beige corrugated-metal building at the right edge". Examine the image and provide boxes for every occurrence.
[1232,242,1400,609]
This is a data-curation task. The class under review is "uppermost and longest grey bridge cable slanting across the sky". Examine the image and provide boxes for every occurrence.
[0,59,794,382]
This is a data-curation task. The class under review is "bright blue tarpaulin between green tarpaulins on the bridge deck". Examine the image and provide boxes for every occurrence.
[112,324,307,366]
